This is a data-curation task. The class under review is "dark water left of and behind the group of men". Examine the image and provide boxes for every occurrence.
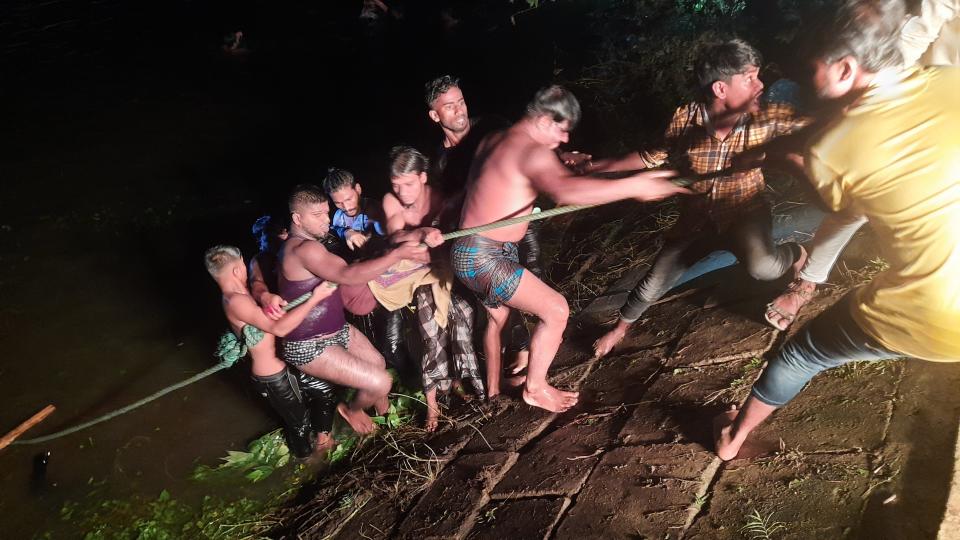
[0,3,600,538]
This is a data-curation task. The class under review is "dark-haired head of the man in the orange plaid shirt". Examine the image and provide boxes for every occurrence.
[693,39,763,111]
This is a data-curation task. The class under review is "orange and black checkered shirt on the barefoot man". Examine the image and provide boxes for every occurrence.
[640,102,810,235]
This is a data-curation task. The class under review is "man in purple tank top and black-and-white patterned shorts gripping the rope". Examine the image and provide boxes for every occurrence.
[278,185,429,433]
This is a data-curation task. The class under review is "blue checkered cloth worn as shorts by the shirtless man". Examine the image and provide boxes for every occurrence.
[451,235,523,308]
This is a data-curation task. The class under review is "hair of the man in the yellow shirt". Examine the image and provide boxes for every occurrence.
[803,0,906,73]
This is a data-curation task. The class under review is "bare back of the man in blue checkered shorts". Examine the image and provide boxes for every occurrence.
[460,126,549,242]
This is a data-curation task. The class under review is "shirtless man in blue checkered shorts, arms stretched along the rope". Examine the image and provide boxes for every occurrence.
[452,86,688,412]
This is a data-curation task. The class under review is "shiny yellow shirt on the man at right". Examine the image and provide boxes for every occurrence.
[807,67,960,361]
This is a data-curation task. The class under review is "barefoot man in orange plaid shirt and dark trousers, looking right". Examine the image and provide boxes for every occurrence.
[585,39,808,357]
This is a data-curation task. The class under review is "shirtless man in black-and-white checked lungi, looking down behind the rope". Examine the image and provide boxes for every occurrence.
[383,146,483,431]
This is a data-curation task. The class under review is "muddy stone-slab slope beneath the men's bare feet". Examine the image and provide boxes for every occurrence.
[271,213,960,539]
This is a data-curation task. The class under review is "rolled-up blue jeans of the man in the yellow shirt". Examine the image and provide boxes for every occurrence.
[751,294,903,407]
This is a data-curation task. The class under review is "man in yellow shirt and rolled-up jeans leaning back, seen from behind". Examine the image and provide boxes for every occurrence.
[715,0,960,460]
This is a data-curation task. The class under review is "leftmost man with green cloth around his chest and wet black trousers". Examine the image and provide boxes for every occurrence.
[204,246,335,457]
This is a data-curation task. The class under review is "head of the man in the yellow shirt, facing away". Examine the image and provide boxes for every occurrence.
[802,0,906,99]
